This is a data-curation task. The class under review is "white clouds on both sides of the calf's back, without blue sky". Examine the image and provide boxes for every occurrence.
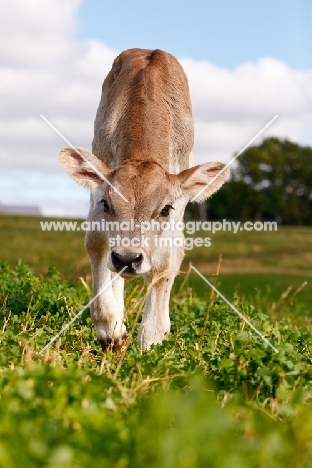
[0,0,312,216]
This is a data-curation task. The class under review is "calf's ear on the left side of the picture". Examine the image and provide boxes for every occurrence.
[59,147,112,189]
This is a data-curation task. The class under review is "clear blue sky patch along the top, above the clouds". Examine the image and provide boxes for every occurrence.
[77,0,312,69]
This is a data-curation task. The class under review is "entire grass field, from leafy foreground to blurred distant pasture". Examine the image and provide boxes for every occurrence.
[0,216,312,468]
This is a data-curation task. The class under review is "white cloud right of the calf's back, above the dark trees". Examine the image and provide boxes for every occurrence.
[181,58,312,162]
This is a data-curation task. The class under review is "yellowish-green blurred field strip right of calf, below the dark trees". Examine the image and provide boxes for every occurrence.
[186,226,312,276]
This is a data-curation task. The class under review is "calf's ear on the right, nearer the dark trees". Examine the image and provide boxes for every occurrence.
[178,162,230,203]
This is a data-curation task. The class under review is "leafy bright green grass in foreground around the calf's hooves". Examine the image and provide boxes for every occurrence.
[0,262,312,468]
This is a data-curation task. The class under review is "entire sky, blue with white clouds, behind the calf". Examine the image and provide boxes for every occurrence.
[0,0,312,216]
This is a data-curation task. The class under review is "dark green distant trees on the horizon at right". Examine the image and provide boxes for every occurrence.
[208,138,312,225]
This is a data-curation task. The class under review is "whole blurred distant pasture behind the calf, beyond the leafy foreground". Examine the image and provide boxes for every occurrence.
[0,215,312,313]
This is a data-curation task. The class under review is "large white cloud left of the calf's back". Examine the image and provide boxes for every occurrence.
[0,0,118,176]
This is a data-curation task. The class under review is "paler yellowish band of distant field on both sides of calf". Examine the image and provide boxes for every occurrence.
[0,215,312,277]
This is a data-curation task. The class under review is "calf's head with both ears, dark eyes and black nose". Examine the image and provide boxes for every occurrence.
[59,148,229,276]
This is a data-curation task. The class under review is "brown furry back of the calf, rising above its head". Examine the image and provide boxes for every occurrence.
[93,49,194,171]
